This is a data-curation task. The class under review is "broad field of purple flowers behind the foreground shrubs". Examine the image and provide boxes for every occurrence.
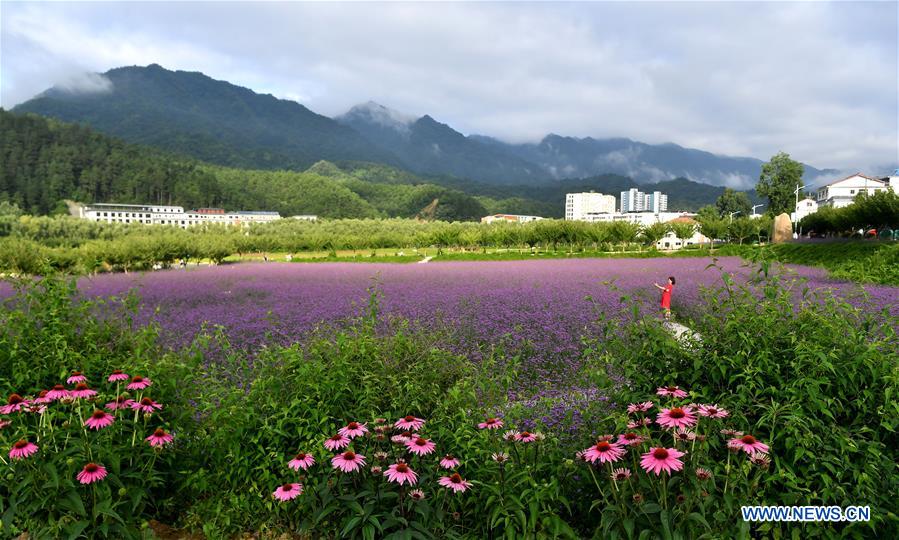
[56,257,899,360]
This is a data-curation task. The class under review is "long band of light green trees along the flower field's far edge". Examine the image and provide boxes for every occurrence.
[0,205,784,273]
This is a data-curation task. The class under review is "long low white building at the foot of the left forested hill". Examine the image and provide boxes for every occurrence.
[78,203,281,228]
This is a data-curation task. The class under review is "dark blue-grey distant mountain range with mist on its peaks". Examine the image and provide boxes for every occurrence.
[13,64,835,194]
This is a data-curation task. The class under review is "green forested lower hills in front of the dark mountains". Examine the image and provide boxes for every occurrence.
[0,109,740,221]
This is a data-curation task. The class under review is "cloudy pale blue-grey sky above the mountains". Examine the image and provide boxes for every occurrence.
[0,0,899,173]
